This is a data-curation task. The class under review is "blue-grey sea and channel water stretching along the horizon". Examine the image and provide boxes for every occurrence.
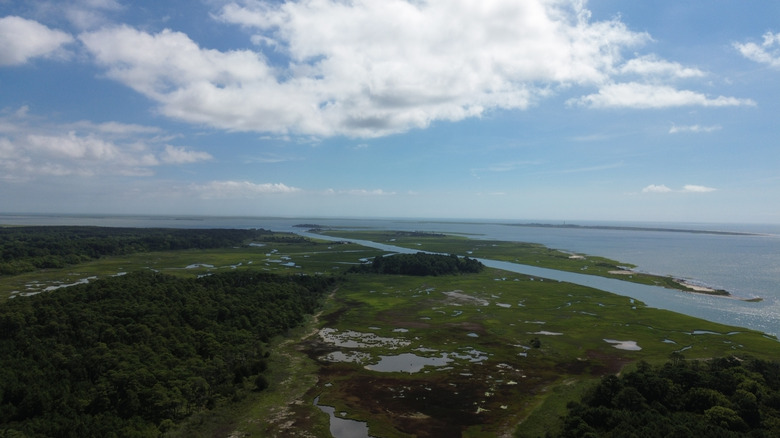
[0,214,780,336]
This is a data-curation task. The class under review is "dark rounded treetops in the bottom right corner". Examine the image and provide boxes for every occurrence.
[558,354,780,438]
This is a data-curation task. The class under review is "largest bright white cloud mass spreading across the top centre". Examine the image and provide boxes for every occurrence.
[80,0,649,137]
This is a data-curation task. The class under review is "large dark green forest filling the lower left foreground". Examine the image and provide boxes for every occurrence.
[0,271,332,437]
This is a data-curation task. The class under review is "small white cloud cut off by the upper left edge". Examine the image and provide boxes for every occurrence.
[0,16,73,66]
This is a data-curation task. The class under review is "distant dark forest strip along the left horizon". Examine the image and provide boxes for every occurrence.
[0,226,274,276]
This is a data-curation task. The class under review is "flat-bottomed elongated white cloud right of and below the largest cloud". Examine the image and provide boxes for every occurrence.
[568,82,755,108]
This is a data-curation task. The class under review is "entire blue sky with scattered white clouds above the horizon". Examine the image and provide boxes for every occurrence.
[0,0,780,224]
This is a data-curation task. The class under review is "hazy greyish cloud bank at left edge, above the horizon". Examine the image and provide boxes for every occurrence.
[0,110,212,181]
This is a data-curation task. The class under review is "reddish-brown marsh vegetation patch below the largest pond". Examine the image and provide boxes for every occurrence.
[310,362,557,437]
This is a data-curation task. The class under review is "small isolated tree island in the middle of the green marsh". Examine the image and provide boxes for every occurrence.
[350,252,485,275]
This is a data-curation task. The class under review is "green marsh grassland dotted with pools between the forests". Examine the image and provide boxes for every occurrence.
[0,231,780,437]
